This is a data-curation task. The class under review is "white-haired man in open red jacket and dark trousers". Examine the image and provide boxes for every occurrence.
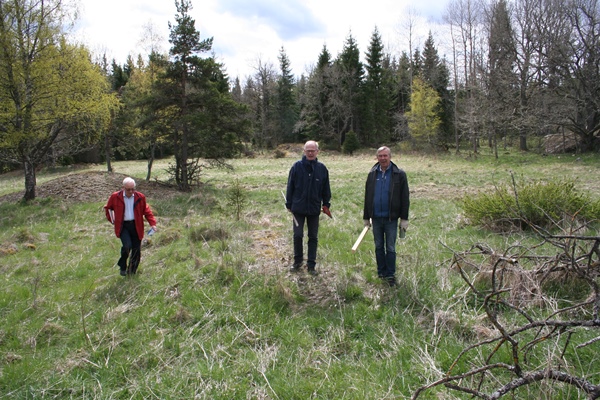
[104,178,156,276]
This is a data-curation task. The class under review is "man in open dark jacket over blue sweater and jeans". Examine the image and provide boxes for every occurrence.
[363,146,410,286]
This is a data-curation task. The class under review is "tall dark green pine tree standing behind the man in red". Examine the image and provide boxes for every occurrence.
[154,0,251,190]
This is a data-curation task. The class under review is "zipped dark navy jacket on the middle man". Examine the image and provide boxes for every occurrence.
[285,156,331,215]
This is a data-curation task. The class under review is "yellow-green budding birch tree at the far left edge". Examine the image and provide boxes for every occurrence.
[0,0,117,200]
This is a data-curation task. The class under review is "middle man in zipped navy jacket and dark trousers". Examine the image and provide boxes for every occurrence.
[285,140,331,275]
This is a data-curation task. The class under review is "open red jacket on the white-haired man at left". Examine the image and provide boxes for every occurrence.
[104,190,156,240]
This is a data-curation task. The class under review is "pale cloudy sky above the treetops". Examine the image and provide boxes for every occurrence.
[73,0,450,82]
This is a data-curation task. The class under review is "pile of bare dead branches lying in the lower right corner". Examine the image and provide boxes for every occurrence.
[412,235,600,399]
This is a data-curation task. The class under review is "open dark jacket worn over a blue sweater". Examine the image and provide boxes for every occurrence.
[363,162,410,220]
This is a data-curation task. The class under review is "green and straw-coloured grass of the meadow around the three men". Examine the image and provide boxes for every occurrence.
[0,151,600,399]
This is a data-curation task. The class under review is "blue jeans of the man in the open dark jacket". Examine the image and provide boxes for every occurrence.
[371,218,398,278]
